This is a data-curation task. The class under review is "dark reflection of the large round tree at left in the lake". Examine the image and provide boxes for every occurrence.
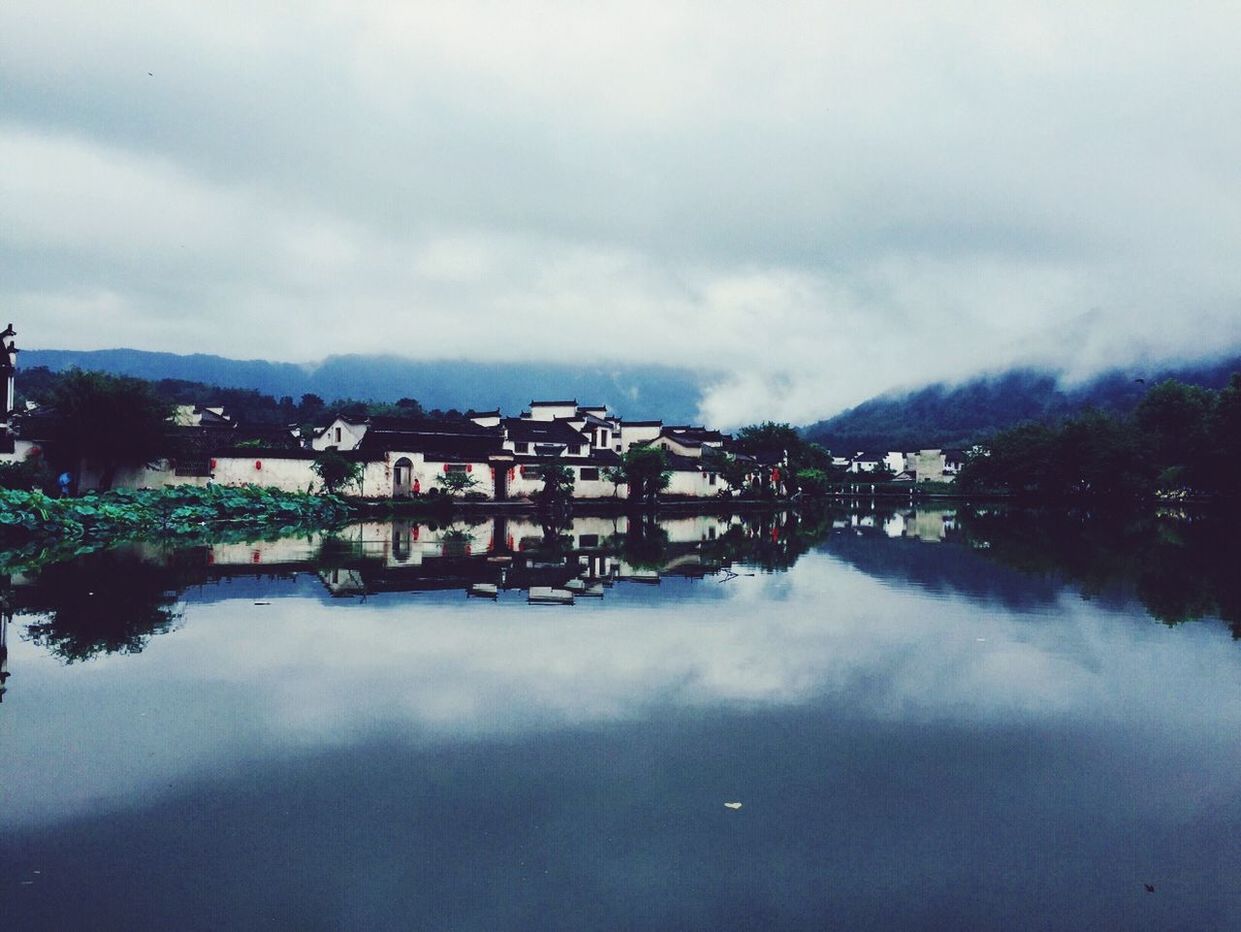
[22,551,187,663]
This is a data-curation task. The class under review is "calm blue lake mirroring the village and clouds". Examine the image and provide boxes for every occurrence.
[0,510,1241,930]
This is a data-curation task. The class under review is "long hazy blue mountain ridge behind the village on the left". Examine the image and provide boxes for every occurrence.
[19,349,719,423]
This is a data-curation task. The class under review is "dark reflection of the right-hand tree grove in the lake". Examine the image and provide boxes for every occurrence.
[958,509,1241,638]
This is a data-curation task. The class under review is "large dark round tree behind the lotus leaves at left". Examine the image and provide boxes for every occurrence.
[51,369,172,489]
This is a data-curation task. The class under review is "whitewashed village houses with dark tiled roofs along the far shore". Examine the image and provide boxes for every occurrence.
[0,325,964,501]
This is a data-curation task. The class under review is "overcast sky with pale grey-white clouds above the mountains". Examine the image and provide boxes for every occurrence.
[0,0,1241,423]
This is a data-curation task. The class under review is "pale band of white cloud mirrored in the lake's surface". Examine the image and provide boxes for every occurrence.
[0,555,1241,820]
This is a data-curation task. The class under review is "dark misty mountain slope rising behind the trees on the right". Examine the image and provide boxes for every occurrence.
[804,356,1241,452]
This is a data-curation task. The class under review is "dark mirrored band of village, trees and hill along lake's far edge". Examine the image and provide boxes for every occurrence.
[0,511,1241,680]
